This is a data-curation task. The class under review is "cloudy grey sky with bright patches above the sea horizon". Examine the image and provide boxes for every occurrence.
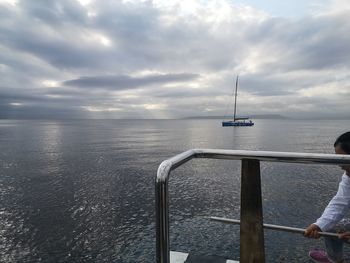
[0,0,350,119]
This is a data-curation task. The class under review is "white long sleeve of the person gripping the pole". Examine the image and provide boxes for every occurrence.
[315,173,350,231]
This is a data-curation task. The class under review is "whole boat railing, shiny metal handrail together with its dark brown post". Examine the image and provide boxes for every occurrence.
[155,149,350,263]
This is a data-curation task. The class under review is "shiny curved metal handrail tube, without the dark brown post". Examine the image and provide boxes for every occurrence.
[155,149,350,263]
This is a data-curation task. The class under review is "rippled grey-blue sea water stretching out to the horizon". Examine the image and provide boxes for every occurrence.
[0,120,350,262]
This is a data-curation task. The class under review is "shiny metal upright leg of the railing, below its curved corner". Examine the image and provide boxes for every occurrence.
[155,178,170,263]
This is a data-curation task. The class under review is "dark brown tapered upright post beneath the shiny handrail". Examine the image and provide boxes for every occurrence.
[240,159,265,263]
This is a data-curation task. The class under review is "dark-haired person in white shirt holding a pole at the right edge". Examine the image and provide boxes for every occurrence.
[304,132,350,263]
